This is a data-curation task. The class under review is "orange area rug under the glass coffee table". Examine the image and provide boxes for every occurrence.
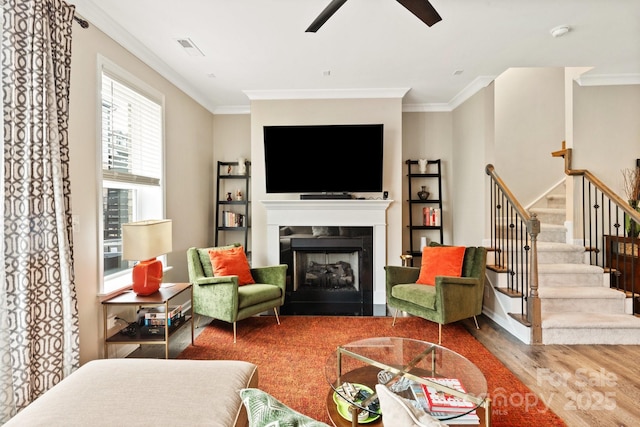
[178,316,565,427]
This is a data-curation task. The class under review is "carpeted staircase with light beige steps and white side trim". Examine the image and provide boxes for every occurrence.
[485,192,640,344]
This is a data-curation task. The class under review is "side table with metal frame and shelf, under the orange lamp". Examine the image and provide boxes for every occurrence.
[102,283,194,359]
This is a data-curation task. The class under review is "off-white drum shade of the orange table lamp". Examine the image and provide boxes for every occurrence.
[122,219,172,261]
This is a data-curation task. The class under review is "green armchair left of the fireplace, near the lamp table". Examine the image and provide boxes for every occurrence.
[187,248,287,343]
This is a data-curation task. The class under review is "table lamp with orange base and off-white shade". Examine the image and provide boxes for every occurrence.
[122,219,171,295]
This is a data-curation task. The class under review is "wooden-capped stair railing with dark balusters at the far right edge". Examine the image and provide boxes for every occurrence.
[552,142,640,315]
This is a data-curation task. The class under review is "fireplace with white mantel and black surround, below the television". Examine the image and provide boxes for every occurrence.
[261,199,392,316]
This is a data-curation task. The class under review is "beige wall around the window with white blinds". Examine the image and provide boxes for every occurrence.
[69,24,213,363]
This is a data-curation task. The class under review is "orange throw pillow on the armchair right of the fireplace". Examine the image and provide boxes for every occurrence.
[416,246,466,286]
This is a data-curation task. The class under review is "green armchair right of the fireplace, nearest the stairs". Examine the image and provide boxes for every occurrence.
[385,247,487,344]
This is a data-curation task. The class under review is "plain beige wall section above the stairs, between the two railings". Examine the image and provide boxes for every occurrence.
[493,68,565,207]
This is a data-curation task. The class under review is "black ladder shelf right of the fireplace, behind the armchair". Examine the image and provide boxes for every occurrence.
[405,159,444,257]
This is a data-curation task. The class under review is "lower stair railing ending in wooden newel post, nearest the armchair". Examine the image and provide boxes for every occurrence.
[485,164,542,344]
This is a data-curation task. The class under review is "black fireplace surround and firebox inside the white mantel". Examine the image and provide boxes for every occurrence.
[280,226,373,316]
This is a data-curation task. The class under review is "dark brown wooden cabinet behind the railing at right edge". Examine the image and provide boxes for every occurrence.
[604,236,640,294]
